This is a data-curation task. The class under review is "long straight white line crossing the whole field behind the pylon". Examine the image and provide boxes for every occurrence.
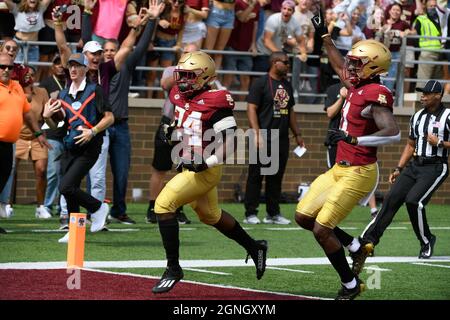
[0,256,450,269]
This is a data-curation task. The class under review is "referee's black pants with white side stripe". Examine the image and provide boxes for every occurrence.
[362,162,448,245]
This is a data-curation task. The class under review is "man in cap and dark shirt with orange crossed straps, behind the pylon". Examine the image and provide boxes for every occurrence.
[43,53,114,243]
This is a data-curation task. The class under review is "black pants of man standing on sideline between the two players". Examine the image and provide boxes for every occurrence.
[244,144,289,217]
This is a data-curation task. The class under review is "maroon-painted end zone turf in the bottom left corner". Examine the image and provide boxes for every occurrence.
[0,269,316,300]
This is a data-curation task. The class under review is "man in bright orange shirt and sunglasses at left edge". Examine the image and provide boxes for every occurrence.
[0,53,50,228]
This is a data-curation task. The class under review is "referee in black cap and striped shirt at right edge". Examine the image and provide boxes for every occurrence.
[350,80,450,271]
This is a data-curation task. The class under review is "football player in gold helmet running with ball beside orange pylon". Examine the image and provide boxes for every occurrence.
[152,51,267,293]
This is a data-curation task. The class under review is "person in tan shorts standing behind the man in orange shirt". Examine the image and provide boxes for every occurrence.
[16,66,52,219]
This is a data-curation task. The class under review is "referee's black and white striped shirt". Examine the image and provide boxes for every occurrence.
[409,104,450,159]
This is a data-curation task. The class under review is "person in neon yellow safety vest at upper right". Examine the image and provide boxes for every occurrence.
[414,0,443,79]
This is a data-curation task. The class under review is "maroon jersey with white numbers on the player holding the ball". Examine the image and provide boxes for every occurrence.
[169,86,234,158]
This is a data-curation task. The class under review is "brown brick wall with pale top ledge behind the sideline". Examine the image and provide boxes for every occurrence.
[15,98,450,204]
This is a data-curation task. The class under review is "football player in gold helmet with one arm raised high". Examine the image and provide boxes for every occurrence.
[295,10,400,300]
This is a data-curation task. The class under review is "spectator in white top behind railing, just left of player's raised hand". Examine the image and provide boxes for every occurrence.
[292,0,319,103]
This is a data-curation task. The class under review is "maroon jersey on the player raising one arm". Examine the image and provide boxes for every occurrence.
[336,83,394,165]
